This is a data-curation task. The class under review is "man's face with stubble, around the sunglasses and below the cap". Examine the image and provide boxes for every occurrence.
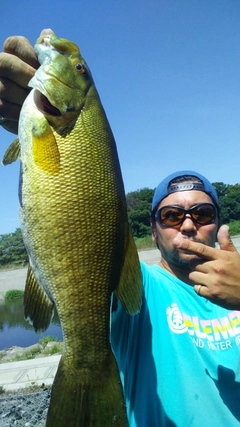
[151,190,218,269]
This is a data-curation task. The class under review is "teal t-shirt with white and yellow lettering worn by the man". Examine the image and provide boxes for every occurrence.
[111,263,240,427]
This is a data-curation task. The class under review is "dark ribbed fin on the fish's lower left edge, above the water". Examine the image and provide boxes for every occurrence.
[24,267,54,332]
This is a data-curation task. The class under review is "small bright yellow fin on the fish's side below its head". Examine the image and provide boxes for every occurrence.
[32,118,60,173]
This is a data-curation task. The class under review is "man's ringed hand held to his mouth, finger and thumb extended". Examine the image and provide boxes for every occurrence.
[174,225,240,310]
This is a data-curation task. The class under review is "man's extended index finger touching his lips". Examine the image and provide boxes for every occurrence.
[173,238,221,260]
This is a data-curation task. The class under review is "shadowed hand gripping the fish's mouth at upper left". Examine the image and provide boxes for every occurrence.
[0,30,52,134]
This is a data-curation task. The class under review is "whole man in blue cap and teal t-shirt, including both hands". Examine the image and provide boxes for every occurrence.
[0,30,240,427]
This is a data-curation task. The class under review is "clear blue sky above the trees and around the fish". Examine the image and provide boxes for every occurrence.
[0,0,240,234]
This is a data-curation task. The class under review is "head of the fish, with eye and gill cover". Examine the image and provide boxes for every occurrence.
[29,34,95,121]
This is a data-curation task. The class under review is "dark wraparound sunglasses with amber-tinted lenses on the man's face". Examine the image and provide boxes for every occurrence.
[155,203,217,227]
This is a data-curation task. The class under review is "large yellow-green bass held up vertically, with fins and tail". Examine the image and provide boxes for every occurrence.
[2,33,142,427]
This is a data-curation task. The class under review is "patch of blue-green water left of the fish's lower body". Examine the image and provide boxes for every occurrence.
[0,298,63,350]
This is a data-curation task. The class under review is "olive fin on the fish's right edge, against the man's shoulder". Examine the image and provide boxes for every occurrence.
[115,225,142,314]
